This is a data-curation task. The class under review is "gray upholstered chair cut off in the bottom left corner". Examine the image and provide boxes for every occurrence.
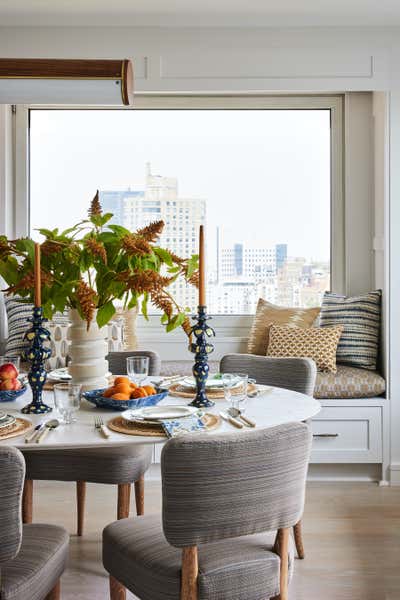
[0,446,69,600]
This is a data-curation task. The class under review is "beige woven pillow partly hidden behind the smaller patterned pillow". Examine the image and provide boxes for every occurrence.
[247,298,321,356]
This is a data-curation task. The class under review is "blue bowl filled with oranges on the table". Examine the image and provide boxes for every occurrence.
[83,377,168,410]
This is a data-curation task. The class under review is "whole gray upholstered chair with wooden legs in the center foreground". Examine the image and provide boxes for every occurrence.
[103,423,311,600]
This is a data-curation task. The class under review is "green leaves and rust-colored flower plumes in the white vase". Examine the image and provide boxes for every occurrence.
[0,192,198,335]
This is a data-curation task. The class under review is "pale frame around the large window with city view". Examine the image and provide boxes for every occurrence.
[14,93,346,328]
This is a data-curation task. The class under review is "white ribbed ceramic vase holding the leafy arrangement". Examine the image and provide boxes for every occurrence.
[68,309,108,391]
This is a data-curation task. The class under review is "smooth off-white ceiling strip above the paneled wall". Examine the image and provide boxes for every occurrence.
[0,0,400,27]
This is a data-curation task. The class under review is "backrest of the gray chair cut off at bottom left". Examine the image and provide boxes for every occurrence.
[0,446,25,566]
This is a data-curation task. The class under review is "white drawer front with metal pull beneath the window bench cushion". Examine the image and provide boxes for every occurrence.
[311,406,382,463]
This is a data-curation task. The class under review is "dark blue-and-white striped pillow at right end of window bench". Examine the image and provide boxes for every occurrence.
[320,290,382,371]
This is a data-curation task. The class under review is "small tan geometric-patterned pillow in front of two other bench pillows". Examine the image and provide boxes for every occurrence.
[267,325,343,373]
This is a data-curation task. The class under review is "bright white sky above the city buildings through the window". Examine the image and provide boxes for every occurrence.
[30,109,330,260]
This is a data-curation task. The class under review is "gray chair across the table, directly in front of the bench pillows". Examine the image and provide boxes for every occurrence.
[220,354,317,558]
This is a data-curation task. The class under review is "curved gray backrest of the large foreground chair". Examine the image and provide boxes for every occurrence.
[161,423,311,548]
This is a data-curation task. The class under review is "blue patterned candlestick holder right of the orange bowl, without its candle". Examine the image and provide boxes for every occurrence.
[189,306,215,408]
